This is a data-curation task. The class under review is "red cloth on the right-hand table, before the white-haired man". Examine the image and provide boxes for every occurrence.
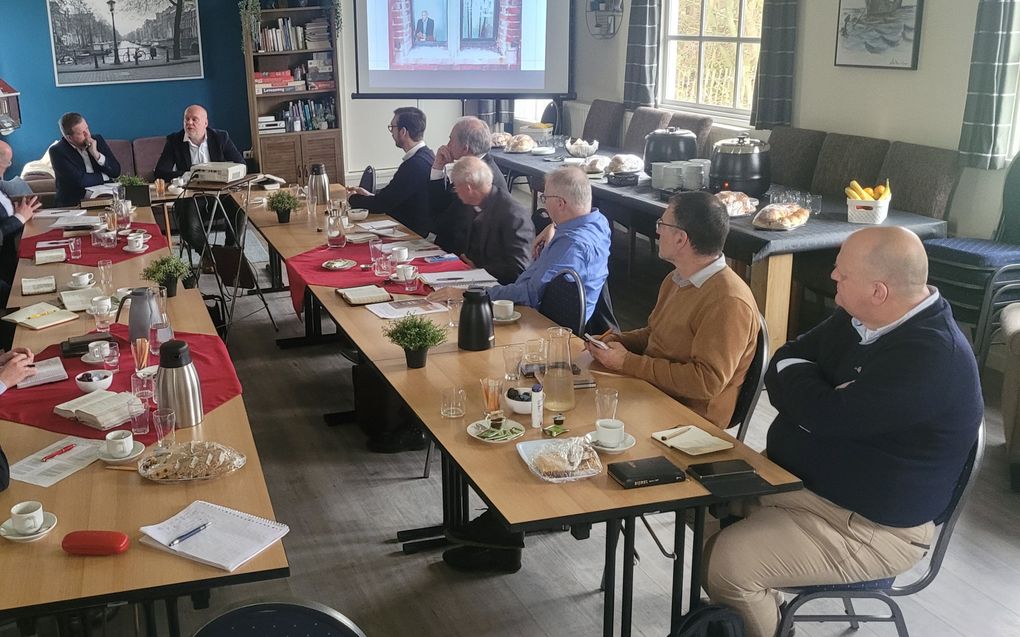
[285,244,470,316]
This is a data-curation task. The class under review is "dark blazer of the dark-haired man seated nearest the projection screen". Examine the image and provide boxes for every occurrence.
[347,146,436,236]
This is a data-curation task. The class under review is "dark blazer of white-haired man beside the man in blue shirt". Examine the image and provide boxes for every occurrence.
[464,188,534,285]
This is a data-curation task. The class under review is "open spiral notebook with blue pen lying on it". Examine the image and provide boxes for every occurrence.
[140,499,291,572]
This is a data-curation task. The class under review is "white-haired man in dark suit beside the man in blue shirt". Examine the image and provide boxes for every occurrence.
[450,156,534,285]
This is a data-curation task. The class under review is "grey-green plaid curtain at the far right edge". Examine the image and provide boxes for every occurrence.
[960,0,1020,169]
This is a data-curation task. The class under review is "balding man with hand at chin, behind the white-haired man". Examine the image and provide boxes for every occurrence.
[428,116,509,255]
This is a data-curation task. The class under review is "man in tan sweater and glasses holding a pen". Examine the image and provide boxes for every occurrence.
[588,188,759,428]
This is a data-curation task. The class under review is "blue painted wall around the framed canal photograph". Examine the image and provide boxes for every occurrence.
[0,0,251,178]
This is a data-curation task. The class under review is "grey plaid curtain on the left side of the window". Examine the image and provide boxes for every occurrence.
[623,0,660,108]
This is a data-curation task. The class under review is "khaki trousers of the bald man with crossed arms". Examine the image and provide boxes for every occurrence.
[704,489,934,637]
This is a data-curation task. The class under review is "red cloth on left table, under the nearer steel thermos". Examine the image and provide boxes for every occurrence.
[0,323,241,445]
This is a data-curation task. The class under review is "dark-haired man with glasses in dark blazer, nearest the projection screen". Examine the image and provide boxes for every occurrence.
[347,106,436,236]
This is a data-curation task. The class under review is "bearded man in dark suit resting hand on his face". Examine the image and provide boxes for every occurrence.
[49,113,120,206]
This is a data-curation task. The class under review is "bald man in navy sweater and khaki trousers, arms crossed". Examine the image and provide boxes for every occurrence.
[706,227,983,637]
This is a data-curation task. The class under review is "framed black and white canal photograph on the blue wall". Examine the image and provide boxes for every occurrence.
[47,0,203,87]
